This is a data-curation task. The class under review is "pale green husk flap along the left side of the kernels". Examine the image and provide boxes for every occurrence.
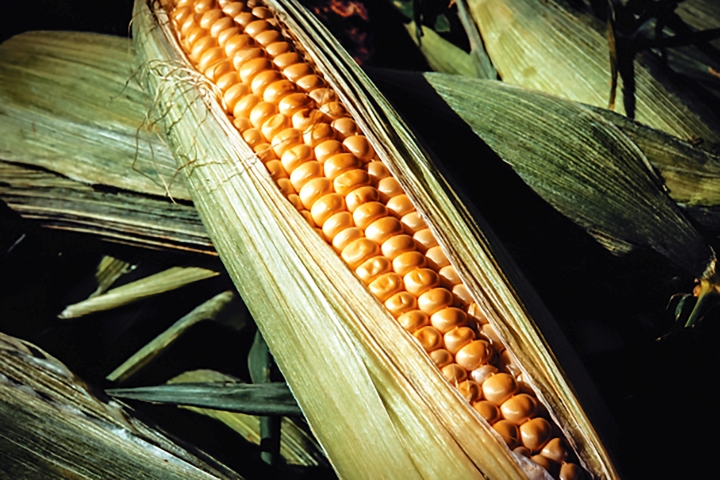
[133,3,500,478]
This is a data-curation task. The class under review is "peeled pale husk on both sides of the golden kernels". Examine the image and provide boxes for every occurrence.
[133,0,616,479]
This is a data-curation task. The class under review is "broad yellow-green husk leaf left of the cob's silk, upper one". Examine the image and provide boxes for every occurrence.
[0,32,189,199]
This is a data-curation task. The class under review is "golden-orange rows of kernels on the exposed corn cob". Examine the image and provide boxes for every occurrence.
[159,0,583,479]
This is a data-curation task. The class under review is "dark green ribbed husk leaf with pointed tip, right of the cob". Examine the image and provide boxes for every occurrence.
[388,73,720,276]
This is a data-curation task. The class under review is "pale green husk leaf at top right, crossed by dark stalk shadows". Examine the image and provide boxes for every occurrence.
[469,0,720,149]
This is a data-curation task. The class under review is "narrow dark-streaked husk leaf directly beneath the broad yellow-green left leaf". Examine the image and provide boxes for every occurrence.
[0,159,215,255]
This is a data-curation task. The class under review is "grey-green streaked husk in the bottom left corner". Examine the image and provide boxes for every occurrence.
[0,333,241,480]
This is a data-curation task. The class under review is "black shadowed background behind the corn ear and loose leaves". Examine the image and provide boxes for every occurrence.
[0,0,720,478]
